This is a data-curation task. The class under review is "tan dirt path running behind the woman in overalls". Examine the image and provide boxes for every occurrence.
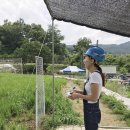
[63,80,127,127]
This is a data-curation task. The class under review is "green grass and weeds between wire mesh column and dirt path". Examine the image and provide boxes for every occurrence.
[42,77,81,130]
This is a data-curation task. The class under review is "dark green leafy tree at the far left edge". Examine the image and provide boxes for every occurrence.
[0,20,23,54]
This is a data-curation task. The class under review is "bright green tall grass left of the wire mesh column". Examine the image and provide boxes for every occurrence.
[0,73,35,130]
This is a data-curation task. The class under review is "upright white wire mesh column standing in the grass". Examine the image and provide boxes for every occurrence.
[35,56,45,130]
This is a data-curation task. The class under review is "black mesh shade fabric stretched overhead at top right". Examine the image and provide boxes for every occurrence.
[44,0,130,37]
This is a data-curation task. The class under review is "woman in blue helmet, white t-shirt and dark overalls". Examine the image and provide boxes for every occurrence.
[70,47,105,130]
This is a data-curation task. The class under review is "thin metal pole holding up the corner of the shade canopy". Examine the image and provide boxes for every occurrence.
[52,17,55,130]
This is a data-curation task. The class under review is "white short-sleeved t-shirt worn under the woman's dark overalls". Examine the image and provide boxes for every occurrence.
[85,72,102,103]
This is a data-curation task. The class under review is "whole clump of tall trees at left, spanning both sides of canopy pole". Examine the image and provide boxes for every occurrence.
[0,19,68,63]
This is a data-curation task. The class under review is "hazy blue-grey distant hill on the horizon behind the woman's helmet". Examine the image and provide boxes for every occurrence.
[67,41,130,54]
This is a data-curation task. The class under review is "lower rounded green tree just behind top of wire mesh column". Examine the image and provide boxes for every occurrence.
[14,41,51,63]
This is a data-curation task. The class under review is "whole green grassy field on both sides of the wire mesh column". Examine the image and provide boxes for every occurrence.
[0,73,79,130]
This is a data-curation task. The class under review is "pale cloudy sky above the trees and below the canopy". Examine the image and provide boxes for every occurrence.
[0,0,130,45]
